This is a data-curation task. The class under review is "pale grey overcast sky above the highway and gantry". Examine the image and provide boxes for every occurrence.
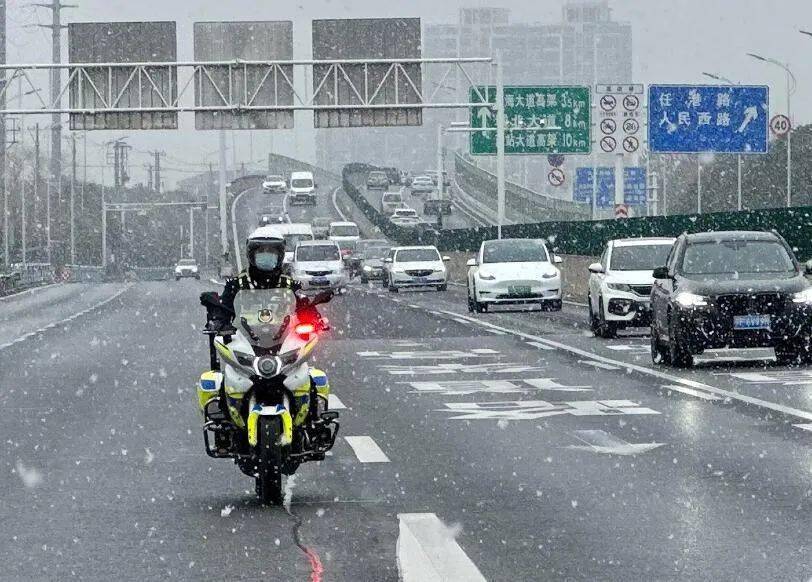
[8,0,812,187]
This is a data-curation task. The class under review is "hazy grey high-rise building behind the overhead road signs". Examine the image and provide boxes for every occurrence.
[317,0,633,185]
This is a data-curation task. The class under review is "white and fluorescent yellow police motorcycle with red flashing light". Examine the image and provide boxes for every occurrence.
[197,289,339,505]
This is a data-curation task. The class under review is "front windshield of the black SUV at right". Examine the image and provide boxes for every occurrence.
[681,240,796,278]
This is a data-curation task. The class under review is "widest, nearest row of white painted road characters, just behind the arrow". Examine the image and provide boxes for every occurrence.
[436,400,660,420]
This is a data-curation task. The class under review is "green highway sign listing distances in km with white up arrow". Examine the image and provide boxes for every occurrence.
[470,85,592,156]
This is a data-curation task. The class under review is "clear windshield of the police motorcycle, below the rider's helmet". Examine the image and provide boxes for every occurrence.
[234,289,296,348]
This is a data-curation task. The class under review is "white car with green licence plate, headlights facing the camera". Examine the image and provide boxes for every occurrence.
[468,239,561,313]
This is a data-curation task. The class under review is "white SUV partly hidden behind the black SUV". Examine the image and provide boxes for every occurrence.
[588,237,674,338]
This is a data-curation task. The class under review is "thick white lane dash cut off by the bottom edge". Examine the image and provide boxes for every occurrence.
[397,513,486,582]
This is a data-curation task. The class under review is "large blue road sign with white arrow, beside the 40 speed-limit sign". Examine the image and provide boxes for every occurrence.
[648,85,770,154]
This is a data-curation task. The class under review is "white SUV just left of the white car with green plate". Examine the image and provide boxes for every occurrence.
[383,246,451,293]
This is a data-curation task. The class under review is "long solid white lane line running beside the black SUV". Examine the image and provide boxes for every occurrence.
[438,311,812,421]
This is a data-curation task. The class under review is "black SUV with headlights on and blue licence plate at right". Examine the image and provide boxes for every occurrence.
[651,231,812,366]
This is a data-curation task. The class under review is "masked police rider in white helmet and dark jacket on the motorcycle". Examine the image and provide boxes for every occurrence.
[200,235,330,330]
